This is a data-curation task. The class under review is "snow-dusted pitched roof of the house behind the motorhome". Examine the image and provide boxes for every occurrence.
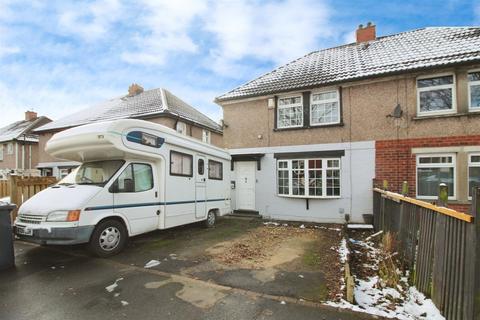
[35,88,222,132]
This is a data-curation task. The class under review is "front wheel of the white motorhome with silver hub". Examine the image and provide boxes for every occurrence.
[90,220,128,258]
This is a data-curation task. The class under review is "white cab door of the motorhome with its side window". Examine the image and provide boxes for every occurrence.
[110,163,160,234]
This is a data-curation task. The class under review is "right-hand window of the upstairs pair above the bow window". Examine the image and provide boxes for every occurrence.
[310,90,340,126]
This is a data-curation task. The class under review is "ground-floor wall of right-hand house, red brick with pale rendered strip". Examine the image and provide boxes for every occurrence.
[375,135,480,212]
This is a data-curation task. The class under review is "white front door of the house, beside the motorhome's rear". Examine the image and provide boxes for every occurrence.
[235,161,257,210]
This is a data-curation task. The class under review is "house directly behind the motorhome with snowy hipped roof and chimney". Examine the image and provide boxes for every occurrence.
[35,84,223,178]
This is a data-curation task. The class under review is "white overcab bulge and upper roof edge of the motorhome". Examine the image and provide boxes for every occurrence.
[46,119,230,162]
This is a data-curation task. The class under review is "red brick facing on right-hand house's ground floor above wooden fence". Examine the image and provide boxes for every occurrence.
[375,135,480,213]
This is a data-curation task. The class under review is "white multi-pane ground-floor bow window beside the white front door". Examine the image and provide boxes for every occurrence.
[277,158,340,198]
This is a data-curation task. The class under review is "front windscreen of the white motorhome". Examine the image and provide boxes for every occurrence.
[75,160,125,186]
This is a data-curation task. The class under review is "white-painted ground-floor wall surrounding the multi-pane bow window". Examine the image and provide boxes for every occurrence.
[230,141,375,223]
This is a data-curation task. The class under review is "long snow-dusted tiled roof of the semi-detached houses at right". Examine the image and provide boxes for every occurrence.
[216,27,480,102]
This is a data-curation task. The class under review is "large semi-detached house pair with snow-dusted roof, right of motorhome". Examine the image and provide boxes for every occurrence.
[216,23,480,222]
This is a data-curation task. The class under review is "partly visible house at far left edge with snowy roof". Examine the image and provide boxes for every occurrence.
[0,111,52,179]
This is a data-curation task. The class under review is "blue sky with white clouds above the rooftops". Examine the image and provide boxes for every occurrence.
[0,0,480,127]
